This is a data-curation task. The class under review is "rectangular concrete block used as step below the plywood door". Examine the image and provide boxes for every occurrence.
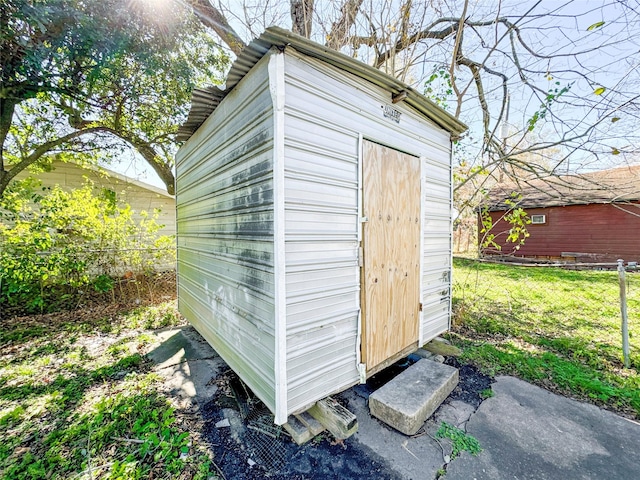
[369,360,458,435]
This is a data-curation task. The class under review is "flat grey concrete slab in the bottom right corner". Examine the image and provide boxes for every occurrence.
[446,377,640,480]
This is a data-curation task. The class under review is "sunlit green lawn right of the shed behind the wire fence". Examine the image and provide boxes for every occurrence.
[451,259,640,418]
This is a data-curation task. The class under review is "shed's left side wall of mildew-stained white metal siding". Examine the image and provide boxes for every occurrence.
[176,58,275,410]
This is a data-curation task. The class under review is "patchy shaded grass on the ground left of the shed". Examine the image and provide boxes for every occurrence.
[0,302,213,480]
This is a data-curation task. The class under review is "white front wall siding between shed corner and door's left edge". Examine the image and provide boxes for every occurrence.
[285,84,359,411]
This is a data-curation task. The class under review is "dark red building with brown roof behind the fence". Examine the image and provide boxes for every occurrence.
[478,166,640,262]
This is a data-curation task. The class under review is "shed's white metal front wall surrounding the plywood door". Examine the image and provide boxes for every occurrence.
[285,49,451,411]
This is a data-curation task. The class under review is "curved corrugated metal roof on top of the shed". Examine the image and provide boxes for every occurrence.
[178,27,467,140]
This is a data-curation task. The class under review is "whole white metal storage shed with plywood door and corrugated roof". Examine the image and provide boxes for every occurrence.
[176,27,465,424]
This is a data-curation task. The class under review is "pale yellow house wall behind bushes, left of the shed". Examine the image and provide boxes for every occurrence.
[16,161,176,236]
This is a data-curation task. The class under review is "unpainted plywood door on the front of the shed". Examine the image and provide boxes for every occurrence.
[361,141,420,371]
